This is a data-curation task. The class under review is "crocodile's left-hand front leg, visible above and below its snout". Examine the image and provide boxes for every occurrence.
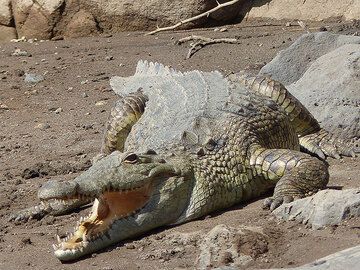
[9,90,148,223]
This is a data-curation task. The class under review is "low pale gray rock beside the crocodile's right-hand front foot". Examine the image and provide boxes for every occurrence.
[273,188,360,229]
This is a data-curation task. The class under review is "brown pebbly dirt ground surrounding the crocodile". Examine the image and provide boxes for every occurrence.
[0,21,360,270]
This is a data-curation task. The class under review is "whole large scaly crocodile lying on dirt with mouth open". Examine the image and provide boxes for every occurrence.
[9,61,354,261]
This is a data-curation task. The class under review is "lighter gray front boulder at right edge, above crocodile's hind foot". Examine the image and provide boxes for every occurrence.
[288,44,360,146]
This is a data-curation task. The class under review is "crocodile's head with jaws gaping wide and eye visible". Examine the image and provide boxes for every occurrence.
[38,151,193,261]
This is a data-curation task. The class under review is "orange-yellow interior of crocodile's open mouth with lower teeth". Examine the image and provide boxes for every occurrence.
[53,184,152,252]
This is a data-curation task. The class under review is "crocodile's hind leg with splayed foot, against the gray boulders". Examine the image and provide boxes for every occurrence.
[229,73,355,159]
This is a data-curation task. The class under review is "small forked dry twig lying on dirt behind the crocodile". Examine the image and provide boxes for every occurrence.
[176,35,240,59]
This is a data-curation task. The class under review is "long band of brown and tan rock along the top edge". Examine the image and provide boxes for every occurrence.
[0,0,360,39]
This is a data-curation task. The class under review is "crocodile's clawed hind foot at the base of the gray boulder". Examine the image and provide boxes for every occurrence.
[299,129,356,159]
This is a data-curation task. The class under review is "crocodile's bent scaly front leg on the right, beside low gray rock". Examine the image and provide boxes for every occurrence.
[250,148,329,210]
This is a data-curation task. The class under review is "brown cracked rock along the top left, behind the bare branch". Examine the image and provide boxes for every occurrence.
[0,0,241,39]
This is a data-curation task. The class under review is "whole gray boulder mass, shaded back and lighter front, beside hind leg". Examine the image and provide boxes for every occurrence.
[260,32,360,151]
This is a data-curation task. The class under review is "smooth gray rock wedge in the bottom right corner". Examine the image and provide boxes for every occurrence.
[216,246,360,270]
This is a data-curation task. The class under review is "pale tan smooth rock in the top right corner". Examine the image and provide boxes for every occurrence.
[247,0,360,21]
